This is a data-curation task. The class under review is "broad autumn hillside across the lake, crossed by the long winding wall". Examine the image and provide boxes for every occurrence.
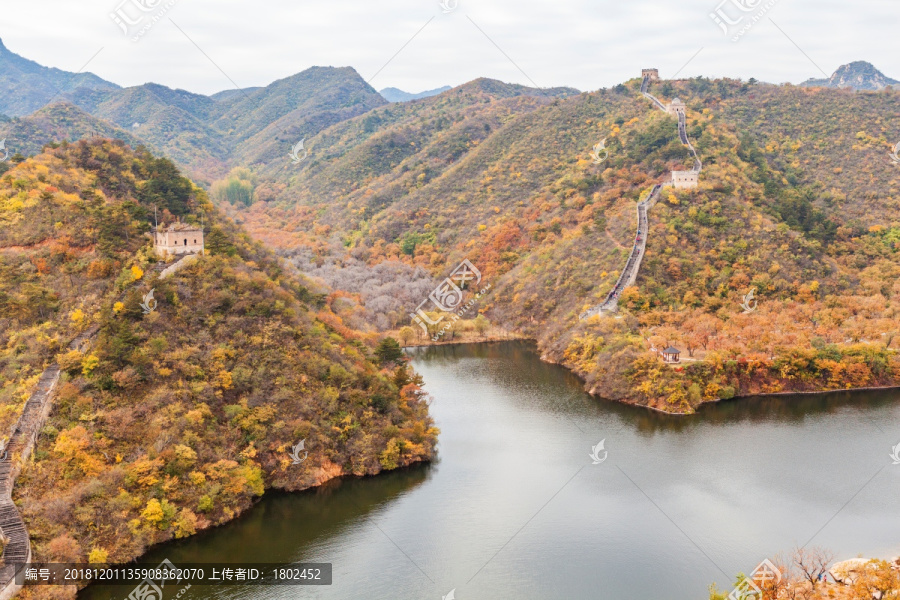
[234,79,900,412]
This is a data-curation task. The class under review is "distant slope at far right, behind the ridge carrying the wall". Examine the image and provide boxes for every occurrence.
[714,81,900,226]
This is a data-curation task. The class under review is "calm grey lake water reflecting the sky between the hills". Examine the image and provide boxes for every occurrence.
[79,342,900,600]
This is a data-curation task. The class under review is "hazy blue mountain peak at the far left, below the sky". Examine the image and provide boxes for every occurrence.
[0,41,119,117]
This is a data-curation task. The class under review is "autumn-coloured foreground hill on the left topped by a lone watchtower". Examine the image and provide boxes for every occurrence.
[0,139,436,562]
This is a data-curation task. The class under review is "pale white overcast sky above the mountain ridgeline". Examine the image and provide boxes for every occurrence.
[0,0,900,94]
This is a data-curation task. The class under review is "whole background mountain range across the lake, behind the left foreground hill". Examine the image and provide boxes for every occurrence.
[0,37,900,412]
